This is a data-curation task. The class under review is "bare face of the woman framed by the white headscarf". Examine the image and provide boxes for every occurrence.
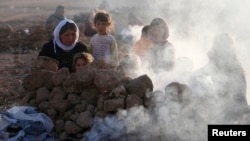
[60,30,76,46]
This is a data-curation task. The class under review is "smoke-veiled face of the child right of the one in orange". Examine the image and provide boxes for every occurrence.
[149,25,164,43]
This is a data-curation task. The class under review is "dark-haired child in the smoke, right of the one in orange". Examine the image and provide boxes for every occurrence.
[146,18,175,72]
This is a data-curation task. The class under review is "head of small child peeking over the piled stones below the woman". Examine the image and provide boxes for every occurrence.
[73,52,94,72]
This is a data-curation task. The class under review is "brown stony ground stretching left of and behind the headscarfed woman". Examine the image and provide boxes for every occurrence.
[0,0,146,111]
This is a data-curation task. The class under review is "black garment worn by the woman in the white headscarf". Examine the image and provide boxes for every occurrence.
[38,40,87,72]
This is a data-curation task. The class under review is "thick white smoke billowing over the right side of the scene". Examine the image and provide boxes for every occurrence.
[75,0,250,141]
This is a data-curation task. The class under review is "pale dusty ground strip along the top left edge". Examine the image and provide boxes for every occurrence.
[0,0,94,22]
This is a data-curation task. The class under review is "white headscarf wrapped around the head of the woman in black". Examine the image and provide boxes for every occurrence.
[54,19,79,53]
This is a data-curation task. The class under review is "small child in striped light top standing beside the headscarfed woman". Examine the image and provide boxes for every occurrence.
[88,11,119,68]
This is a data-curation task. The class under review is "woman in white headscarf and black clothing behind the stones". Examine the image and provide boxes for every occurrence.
[38,19,87,72]
